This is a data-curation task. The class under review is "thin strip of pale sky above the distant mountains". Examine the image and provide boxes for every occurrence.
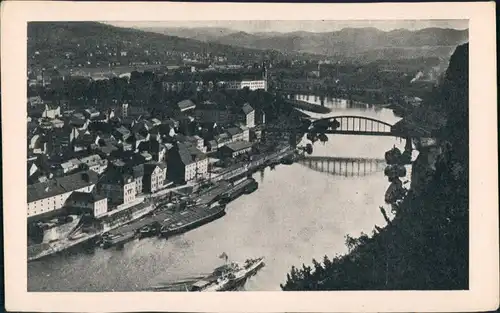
[106,20,468,33]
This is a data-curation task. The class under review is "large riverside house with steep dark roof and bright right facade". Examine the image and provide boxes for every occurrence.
[167,143,208,182]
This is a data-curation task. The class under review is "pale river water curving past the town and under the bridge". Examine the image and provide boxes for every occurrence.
[28,96,404,291]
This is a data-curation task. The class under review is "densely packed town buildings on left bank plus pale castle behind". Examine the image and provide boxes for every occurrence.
[27,68,267,222]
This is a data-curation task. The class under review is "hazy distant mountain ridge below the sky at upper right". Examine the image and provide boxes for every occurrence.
[142,27,469,58]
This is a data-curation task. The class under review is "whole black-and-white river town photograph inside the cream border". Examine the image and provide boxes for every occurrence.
[21,21,468,291]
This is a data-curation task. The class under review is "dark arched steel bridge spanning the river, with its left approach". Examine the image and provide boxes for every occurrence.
[264,115,398,137]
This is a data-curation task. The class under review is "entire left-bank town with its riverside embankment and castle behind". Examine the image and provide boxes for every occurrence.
[27,56,304,258]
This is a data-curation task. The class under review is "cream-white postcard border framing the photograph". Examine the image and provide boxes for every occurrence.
[1,1,499,312]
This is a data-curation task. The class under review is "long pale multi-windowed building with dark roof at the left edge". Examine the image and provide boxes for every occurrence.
[28,171,98,218]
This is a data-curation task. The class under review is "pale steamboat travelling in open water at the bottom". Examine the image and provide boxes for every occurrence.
[189,257,264,292]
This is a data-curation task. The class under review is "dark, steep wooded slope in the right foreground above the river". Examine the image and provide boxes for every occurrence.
[281,44,469,290]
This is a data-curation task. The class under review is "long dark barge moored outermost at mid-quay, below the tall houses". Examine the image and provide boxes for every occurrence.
[160,203,226,238]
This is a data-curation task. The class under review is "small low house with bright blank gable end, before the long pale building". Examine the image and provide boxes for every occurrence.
[65,191,108,218]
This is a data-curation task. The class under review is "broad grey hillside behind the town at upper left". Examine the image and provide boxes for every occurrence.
[28,22,282,67]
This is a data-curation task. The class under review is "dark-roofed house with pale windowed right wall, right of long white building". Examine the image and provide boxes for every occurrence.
[98,169,137,205]
